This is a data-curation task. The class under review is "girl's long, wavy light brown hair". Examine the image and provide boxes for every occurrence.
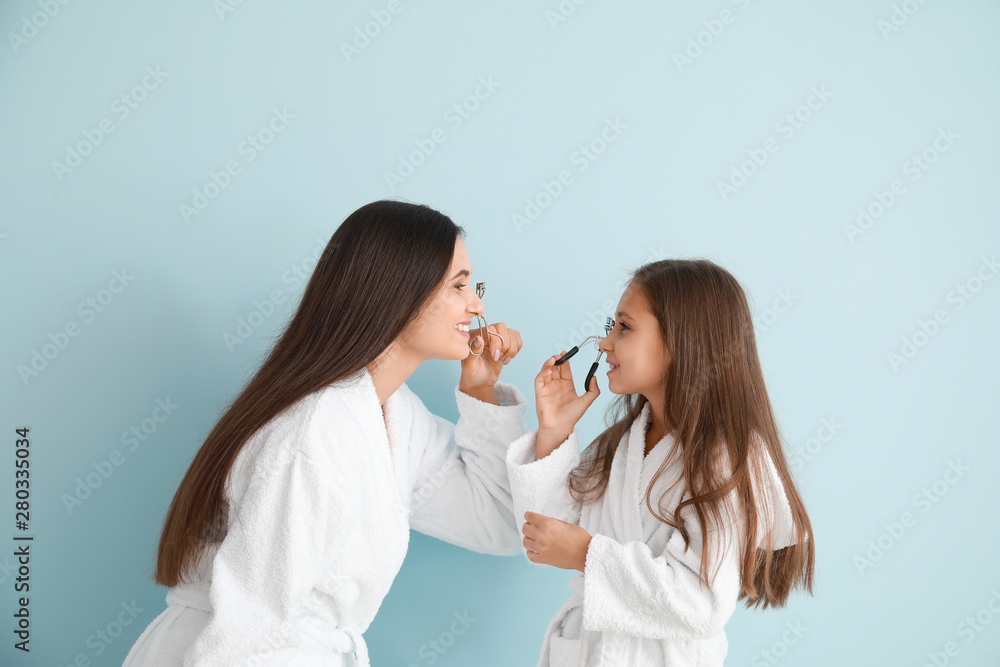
[569,259,815,608]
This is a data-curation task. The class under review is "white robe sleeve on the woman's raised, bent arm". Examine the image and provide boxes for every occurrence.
[410,382,528,555]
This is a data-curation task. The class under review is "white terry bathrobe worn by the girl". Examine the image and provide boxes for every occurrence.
[507,403,794,667]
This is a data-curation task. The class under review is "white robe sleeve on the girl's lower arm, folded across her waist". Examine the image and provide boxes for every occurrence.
[583,508,740,639]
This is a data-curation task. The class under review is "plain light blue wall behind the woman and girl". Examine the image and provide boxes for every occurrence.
[0,0,1000,667]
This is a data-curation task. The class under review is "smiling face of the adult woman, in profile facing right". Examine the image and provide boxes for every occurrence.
[403,238,483,359]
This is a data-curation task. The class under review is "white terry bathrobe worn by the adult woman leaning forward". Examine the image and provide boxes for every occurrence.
[124,369,527,667]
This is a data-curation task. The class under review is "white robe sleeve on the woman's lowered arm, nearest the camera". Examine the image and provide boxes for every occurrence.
[191,447,356,667]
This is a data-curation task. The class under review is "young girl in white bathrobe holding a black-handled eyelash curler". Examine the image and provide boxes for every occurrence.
[507,260,815,667]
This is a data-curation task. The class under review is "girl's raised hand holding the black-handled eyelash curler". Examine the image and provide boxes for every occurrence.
[535,350,601,461]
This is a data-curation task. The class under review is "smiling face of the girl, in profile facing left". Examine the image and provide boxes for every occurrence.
[598,283,670,396]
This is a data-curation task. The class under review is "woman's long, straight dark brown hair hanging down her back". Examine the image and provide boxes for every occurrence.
[153,201,465,586]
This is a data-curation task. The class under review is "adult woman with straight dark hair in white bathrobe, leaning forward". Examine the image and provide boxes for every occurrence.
[125,201,527,667]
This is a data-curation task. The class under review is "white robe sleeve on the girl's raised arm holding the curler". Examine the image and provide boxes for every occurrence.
[507,429,581,532]
